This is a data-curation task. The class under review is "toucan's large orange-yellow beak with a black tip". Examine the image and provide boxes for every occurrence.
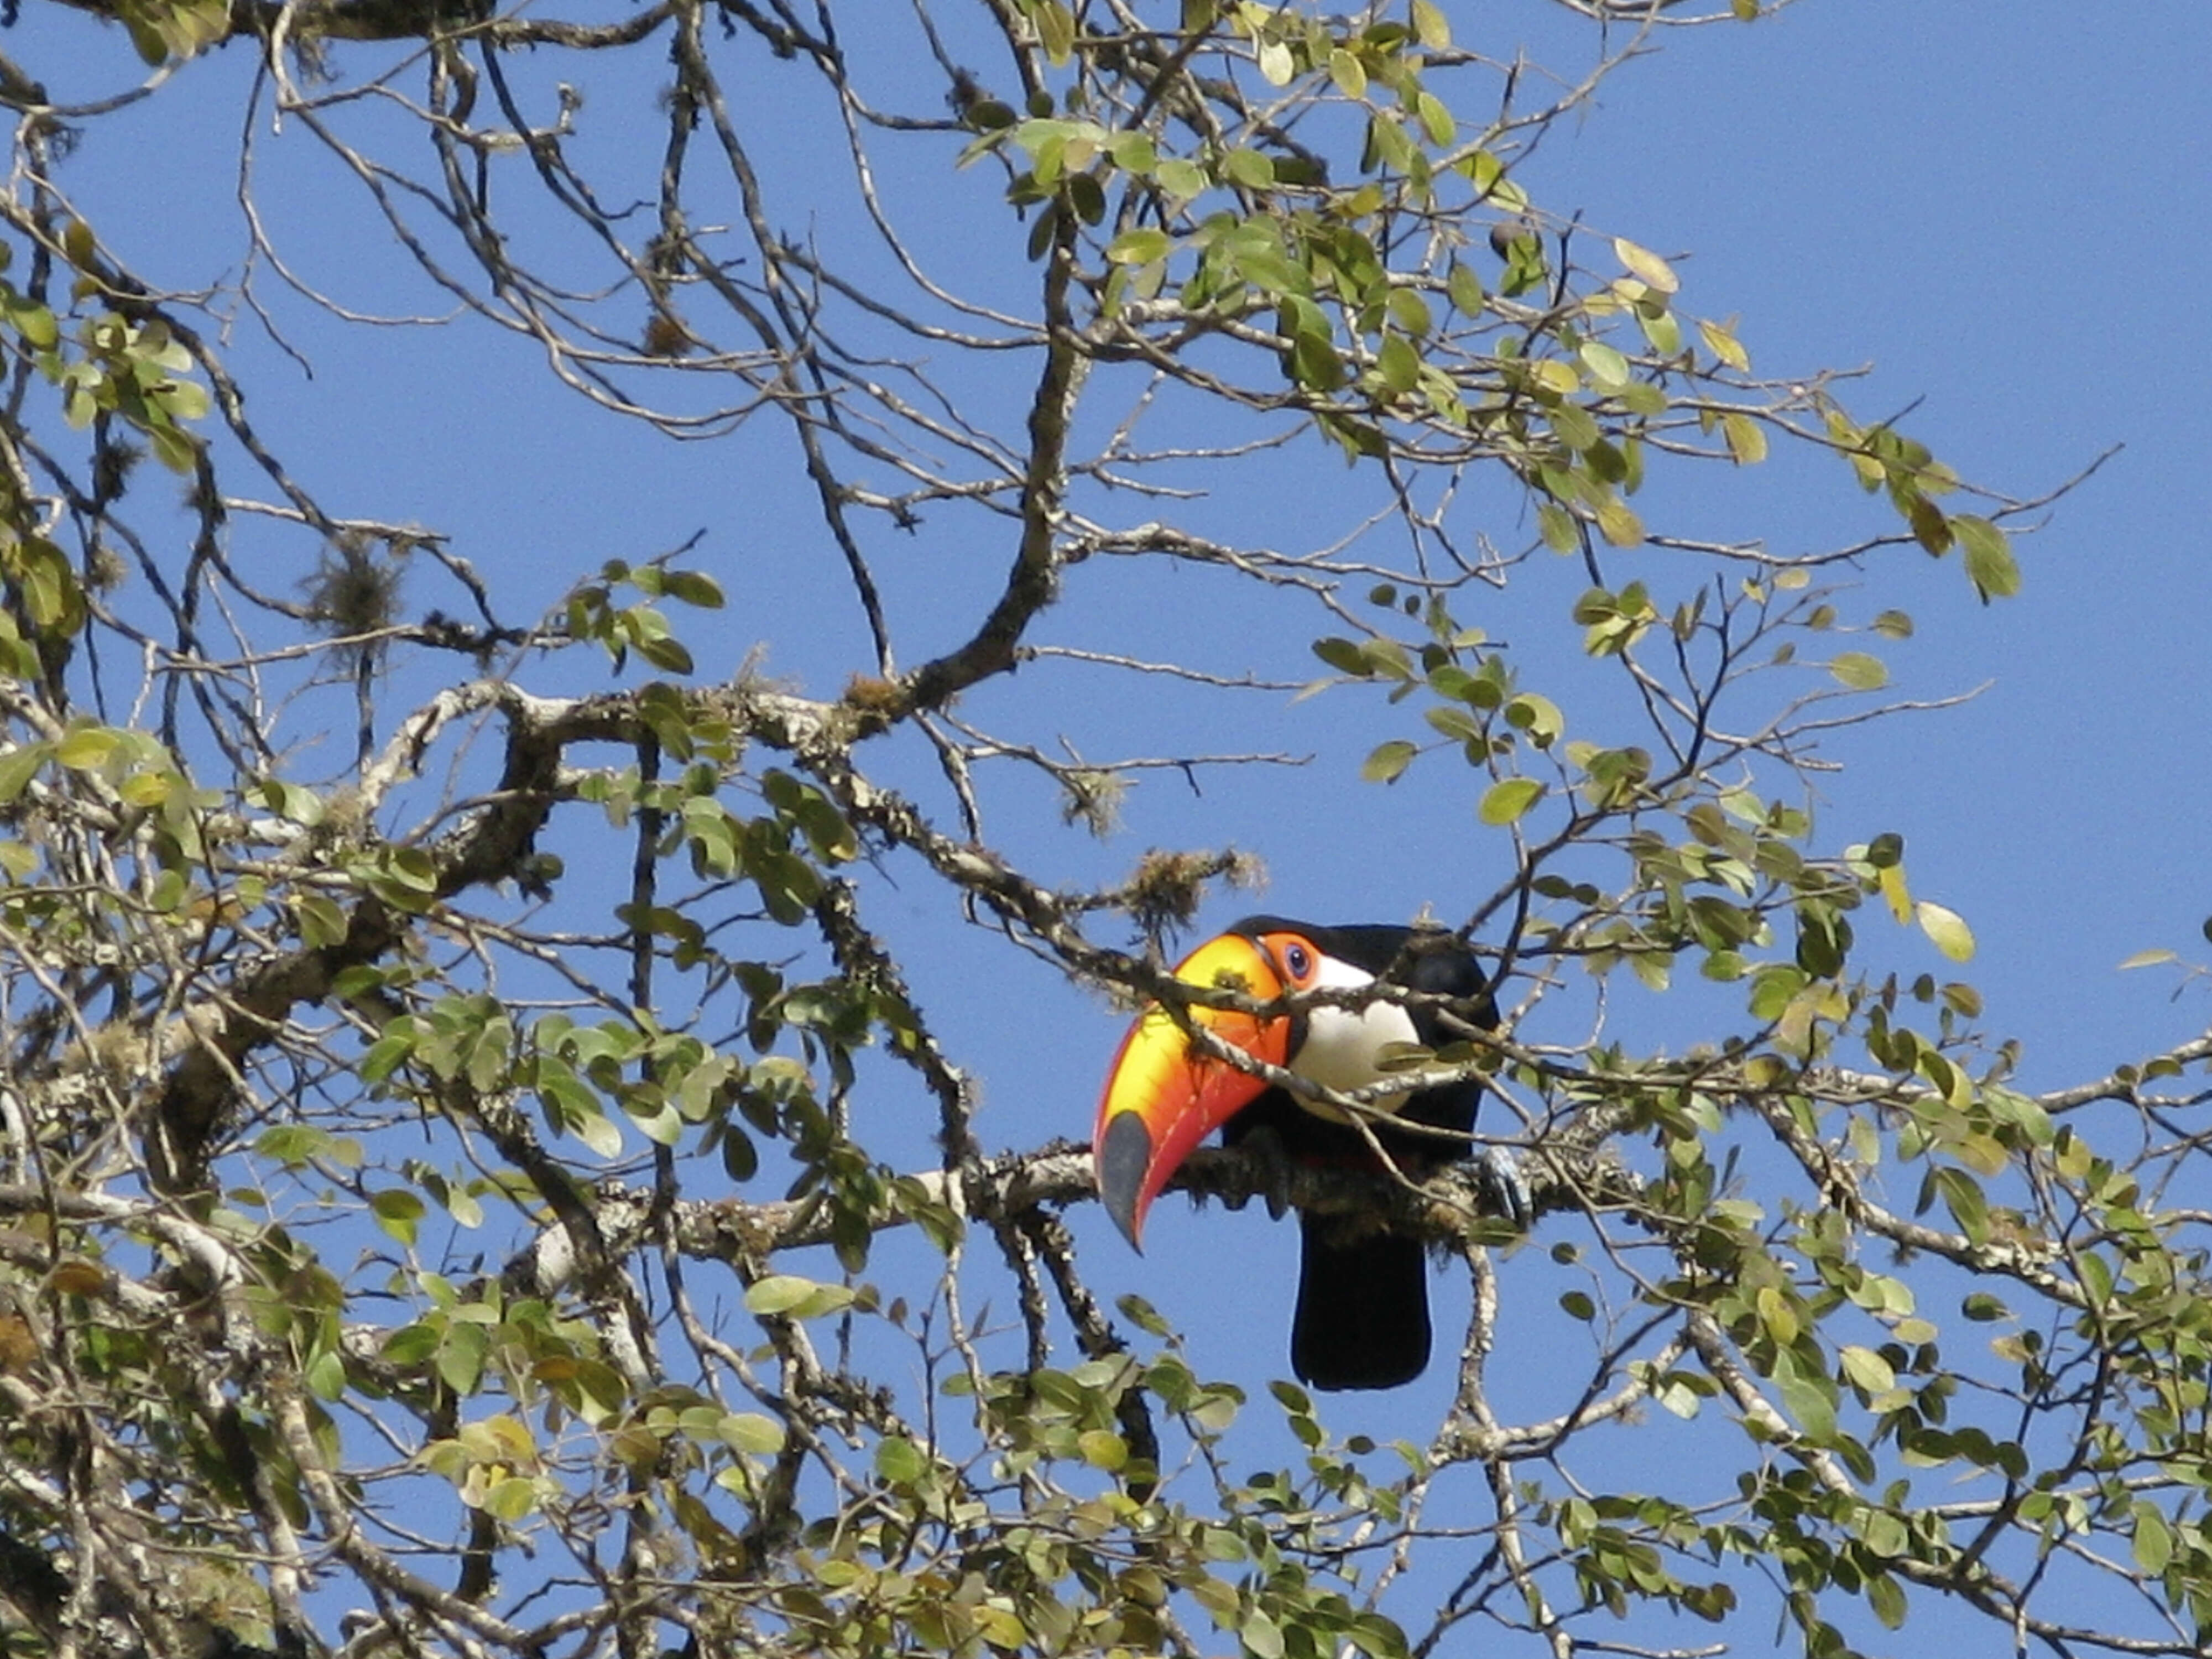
[1091,933,1290,1250]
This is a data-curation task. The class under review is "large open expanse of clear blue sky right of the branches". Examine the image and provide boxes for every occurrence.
[1546,4,2212,1084]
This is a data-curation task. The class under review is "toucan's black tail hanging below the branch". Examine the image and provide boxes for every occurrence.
[1290,1214,1429,1389]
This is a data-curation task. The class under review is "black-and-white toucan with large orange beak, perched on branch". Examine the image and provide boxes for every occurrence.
[1093,916,1526,1389]
